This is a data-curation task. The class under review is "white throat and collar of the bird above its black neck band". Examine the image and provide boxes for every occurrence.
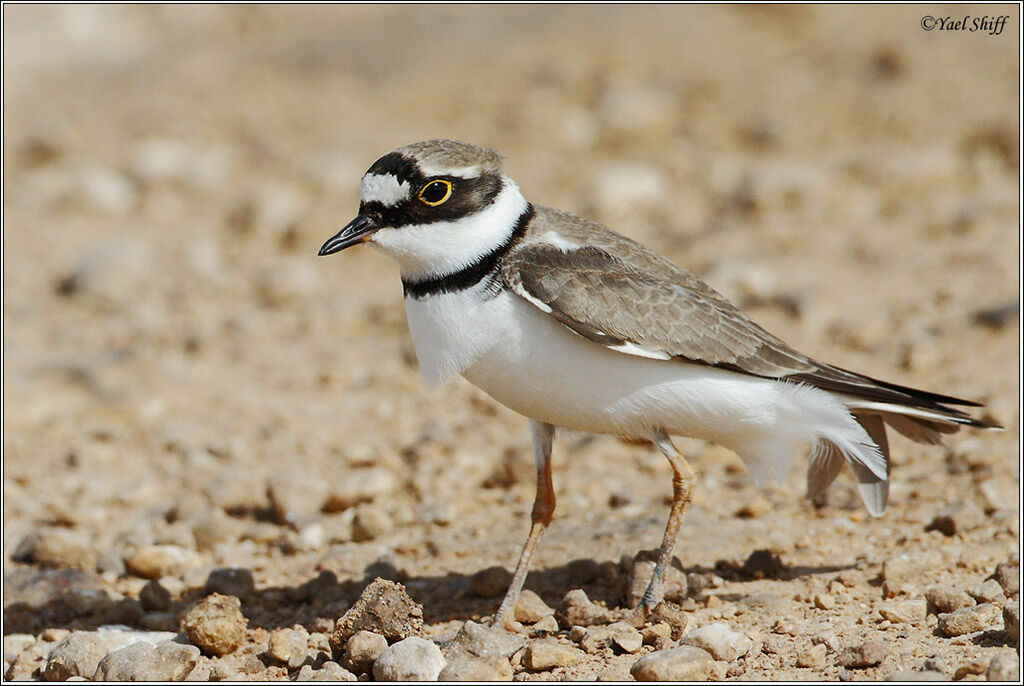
[370,176,527,281]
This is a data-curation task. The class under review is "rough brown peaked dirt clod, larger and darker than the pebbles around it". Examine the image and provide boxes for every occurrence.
[331,577,423,653]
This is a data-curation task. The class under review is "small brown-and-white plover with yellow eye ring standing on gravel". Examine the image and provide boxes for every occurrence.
[318,139,1000,629]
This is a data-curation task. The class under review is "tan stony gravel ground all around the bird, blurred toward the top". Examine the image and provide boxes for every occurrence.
[3,5,1021,680]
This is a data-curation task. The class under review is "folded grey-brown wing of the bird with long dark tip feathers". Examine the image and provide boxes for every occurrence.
[502,236,977,423]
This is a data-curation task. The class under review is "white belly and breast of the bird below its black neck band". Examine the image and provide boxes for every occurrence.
[406,284,863,483]
